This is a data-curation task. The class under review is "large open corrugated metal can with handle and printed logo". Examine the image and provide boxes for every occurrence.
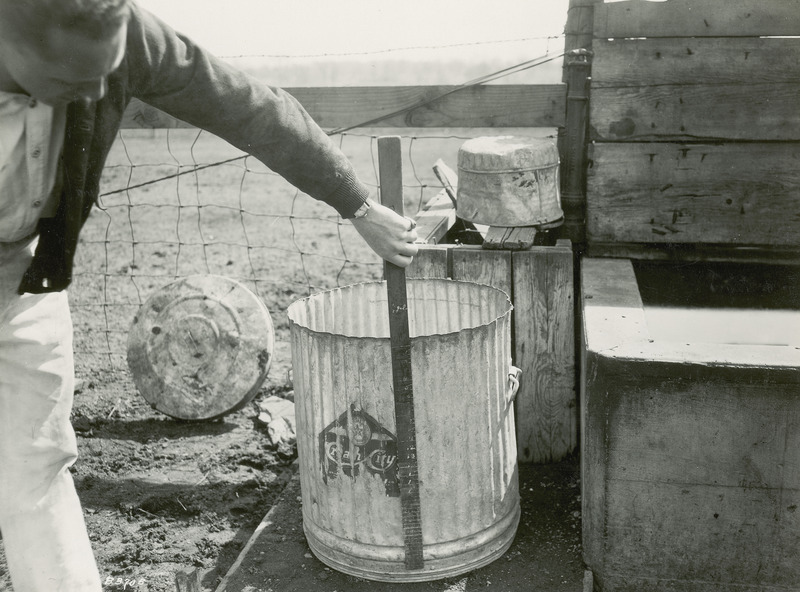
[289,279,519,581]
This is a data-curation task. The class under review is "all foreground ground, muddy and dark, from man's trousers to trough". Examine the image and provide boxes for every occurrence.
[0,352,583,592]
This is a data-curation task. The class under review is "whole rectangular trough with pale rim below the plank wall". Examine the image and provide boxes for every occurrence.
[581,258,800,592]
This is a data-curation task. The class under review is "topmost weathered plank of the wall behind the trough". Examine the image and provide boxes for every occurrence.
[594,0,800,39]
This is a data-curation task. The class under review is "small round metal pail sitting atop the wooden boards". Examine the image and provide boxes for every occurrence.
[456,136,564,227]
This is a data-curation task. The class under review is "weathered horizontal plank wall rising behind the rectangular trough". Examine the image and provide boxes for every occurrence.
[586,0,800,261]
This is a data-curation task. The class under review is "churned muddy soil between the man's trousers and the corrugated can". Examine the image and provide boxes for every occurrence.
[0,350,294,592]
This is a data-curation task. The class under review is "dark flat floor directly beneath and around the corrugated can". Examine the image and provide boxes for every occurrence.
[225,455,591,592]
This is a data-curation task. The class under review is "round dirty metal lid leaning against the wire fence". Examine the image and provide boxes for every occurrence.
[128,275,275,420]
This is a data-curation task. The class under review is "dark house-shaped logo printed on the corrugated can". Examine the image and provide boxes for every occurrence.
[319,405,400,497]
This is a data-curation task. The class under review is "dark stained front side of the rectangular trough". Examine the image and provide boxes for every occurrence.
[584,360,800,592]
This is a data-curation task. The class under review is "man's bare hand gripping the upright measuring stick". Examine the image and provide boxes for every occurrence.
[351,200,419,267]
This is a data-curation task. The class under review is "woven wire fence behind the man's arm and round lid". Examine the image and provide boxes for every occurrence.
[70,45,561,380]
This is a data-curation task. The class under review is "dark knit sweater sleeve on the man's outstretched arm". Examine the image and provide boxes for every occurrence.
[126,4,369,217]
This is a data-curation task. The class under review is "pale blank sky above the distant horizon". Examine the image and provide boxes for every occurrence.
[139,0,568,57]
